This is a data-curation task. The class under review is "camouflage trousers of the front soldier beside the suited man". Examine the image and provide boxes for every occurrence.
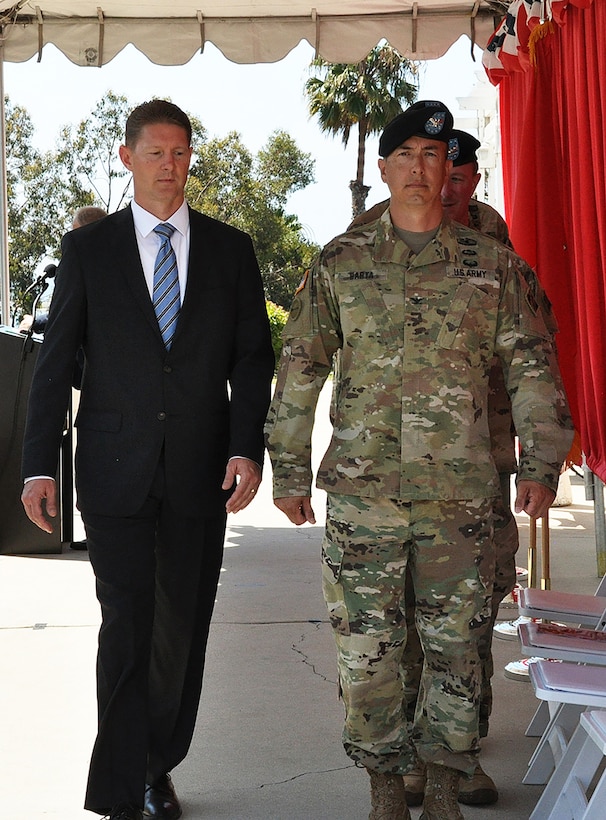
[322,494,495,774]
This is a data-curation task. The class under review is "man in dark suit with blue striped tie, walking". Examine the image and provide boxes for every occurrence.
[22,100,273,820]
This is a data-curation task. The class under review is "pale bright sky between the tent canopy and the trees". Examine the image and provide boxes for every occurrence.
[4,32,484,250]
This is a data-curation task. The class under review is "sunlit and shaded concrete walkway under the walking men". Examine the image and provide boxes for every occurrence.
[0,386,598,820]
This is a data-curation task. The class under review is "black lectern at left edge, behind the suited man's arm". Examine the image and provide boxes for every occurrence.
[0,325,64,555]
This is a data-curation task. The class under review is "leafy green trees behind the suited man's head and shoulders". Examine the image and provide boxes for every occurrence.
[6,91,319,318]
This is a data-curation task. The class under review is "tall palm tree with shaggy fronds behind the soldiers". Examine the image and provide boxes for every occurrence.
[305,44,418,217]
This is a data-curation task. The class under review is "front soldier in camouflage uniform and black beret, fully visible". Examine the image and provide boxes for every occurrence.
[266,101,572,820]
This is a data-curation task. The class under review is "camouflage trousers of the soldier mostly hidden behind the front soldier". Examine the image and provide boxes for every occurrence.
[402,474,520,737]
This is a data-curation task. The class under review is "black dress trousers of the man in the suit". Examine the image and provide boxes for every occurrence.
[82,464,226,814]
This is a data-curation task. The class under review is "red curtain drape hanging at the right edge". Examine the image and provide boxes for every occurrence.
[499,0,606,481]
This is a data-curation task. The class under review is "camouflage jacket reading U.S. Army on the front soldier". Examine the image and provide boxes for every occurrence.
[266,211,572,500]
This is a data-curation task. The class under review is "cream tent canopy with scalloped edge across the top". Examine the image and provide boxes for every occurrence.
[0,0,506,66]
